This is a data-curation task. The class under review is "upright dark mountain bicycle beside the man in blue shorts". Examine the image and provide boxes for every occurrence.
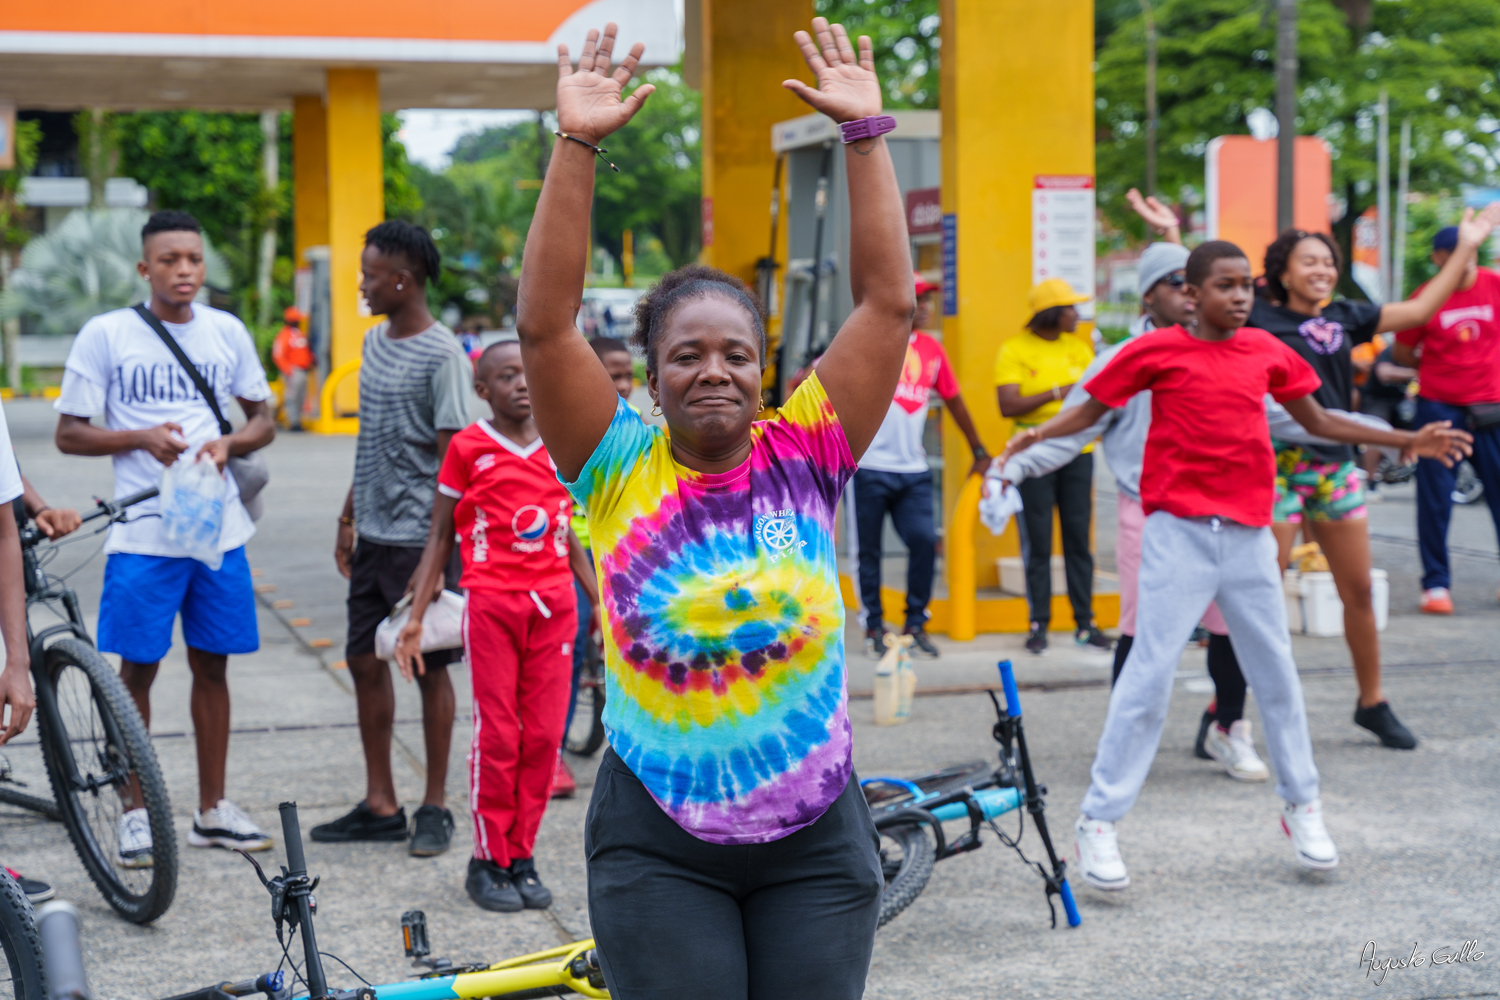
[0,487,177,924]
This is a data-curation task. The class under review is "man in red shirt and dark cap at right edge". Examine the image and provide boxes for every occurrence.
[1392,226,1500,615]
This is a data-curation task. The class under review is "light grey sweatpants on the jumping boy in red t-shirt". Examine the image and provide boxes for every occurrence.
[1082,510,1319,822]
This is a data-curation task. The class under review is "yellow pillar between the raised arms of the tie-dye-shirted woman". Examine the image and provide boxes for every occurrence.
[701,0,813,288]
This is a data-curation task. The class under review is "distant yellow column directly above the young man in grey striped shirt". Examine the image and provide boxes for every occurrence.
[327,69,386,412]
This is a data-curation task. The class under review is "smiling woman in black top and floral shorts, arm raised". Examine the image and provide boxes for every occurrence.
[1248,215,1500,750]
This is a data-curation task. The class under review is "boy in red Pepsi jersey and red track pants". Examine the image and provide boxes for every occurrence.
[396,340,599,913]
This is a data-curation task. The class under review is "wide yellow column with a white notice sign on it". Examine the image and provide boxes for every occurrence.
[939,0,1103,611]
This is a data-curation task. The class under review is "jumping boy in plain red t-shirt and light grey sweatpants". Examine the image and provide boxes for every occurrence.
[1002,240,1469,891]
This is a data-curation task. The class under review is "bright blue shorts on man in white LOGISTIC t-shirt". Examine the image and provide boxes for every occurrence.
[99,546,261,663]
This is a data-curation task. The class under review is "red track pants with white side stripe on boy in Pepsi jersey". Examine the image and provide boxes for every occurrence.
[464,582,578,868]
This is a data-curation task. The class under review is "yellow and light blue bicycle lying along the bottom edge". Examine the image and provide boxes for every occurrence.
[27,802,609,1000]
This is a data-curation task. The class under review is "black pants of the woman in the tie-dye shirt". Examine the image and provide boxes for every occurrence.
[584,750,884,1000]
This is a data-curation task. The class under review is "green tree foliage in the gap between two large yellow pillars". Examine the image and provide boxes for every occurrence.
[813,0,936,108]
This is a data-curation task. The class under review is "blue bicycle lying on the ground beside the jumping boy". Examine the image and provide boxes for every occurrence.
[860,660,1083,927]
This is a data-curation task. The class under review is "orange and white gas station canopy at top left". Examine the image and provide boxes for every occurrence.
[0,0,683,111]
